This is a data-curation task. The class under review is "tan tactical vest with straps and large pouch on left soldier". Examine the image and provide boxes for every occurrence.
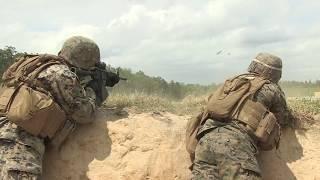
[0,54,66,138]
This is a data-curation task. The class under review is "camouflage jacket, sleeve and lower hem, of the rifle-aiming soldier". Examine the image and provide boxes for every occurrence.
[0,64,96,146]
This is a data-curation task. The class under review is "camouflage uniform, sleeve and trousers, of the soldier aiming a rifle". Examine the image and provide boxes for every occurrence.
[0,65,96,180]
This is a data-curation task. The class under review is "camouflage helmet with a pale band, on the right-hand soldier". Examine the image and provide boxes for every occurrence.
[248,53,282,83]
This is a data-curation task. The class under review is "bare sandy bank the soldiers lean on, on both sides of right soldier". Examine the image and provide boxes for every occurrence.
[43,110,320,180]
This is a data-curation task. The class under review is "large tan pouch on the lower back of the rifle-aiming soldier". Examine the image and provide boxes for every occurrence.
[0,84,66,139]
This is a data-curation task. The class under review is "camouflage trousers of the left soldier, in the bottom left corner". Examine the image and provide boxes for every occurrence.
[0,117,44,180]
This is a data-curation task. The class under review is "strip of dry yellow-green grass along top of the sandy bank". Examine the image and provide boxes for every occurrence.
[105,92,320,115]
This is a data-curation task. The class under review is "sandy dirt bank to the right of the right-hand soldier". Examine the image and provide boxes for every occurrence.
[259,123,320,180]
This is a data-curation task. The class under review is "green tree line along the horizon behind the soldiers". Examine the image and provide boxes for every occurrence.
[0,46,320,99]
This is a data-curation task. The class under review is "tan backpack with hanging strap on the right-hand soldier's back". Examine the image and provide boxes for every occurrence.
[186,74,269,161]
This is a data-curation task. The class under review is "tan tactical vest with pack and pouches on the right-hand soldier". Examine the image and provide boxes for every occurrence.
[186,74,280,160]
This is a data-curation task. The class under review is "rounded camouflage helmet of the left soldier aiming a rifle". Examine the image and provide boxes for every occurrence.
[59,36,100,69]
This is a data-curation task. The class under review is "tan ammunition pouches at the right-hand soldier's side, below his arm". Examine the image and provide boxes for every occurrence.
[233,99,280,150]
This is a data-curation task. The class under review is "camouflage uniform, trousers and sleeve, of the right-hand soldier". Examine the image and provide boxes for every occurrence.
[192,78,290,180]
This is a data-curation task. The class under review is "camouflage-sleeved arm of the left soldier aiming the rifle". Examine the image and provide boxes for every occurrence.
[39,65,96,123]
